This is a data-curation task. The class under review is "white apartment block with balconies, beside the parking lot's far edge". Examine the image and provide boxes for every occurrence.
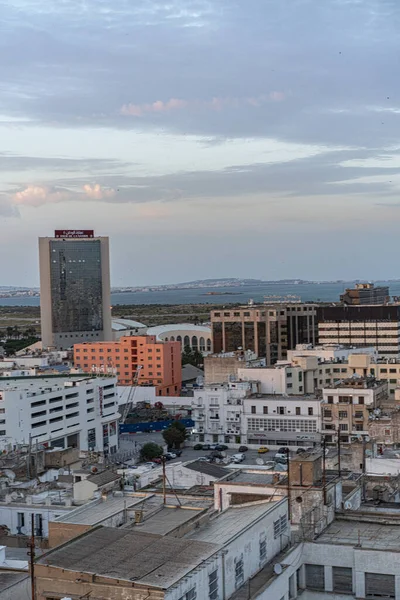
[192,381,258,444]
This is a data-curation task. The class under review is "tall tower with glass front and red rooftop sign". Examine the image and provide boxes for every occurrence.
[39,230,112,349]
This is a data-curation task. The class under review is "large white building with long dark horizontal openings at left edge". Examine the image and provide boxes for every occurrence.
[0,374,120,453]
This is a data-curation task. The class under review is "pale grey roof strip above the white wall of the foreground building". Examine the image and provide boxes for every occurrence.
[187,497,283,545]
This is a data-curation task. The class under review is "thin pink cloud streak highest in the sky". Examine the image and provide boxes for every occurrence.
[120,91,285,117]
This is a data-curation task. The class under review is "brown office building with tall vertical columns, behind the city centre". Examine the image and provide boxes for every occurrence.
[211,302,318,365]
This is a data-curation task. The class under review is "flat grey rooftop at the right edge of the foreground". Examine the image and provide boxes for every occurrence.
[315,515,400,552]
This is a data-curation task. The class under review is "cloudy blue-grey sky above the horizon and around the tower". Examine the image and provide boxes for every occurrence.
[0,0,400,286]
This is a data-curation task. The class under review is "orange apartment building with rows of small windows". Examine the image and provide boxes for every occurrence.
[74,335,182,396]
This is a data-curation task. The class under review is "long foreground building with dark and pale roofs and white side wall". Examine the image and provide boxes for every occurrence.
[35,498,290,600]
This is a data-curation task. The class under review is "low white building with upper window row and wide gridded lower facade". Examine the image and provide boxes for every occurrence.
[241,394,321,449]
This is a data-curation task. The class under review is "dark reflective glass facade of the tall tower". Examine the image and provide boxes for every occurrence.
[50,239,103,333]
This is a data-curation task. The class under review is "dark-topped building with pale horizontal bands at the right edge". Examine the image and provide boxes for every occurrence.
[317,304,400,358]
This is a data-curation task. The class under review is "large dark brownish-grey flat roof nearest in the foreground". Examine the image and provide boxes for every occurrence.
[38,527,221,589]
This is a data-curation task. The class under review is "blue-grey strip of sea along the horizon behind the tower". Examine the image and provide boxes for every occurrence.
[0,281,400,306]
